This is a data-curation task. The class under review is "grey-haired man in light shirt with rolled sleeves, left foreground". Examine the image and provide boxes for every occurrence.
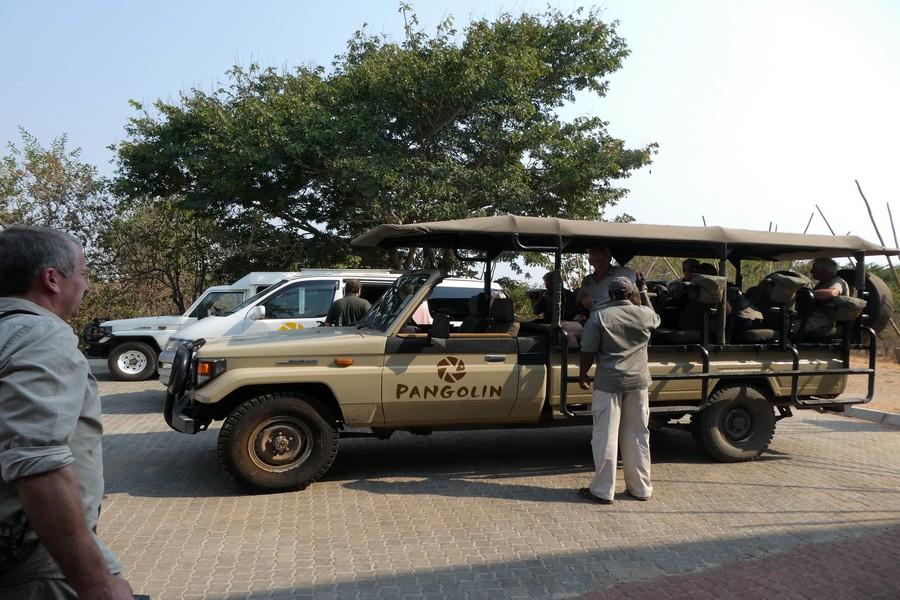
[0,226,132,600]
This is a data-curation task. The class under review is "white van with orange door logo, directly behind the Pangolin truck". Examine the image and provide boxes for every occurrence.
[159,270,503,385]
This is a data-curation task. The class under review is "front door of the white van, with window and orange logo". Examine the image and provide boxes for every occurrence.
[243,278,339,335]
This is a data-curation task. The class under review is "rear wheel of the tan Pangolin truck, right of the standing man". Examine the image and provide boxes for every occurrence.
[693,384,775,462]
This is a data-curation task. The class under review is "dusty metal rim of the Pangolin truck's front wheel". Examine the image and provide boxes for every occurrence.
[247,416,313,473]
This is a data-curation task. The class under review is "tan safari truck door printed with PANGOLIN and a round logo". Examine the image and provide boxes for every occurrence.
[382,273,519,426]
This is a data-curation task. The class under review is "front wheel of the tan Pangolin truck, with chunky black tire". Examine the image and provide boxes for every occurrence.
[218,393,340,492]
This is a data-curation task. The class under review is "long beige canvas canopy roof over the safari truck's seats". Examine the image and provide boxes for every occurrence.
[353,215,900,263]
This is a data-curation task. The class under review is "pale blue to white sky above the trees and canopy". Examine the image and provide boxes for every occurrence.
[0,0,900,251]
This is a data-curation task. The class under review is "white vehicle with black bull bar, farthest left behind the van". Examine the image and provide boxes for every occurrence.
[81,271,301,381]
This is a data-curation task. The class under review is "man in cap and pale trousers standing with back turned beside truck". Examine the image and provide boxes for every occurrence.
[578,273,659,504]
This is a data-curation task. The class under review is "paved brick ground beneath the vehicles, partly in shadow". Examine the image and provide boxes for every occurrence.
[93,366,900,600]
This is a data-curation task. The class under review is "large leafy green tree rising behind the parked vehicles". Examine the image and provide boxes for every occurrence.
[116,5,655,267]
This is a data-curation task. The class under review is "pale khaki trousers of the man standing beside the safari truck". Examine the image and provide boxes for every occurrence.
[590,390,653,500]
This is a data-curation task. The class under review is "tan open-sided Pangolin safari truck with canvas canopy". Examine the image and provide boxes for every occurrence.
[165,216,897,491]
